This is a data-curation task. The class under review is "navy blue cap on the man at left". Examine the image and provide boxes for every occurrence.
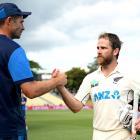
[0,3,31,20]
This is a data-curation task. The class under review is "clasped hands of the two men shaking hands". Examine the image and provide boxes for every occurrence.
[52,69,67,87]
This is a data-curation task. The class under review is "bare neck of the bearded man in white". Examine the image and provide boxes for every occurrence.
[101,61,118,76]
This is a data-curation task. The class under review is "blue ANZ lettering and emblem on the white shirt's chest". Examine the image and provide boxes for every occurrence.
[92,90,120,102]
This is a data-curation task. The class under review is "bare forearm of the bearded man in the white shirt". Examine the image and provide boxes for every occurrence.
[57,86,83,113]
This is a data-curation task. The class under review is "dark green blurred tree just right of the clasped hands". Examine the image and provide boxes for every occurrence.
[66,67,86,93]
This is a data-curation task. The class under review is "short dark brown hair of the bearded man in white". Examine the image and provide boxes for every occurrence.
[98,33,123,59]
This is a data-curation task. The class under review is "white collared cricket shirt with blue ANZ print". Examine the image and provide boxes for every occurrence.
[75,66,139,131]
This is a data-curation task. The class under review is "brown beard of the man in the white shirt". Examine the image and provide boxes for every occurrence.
[97,56,113,66]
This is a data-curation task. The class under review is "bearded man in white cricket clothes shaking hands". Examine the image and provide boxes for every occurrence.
[52,33,140,140]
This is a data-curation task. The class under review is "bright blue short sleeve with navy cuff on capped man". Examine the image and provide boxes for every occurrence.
[8,47,33,83]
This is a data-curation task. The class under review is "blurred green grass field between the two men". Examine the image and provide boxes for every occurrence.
[27,110,140,140]
